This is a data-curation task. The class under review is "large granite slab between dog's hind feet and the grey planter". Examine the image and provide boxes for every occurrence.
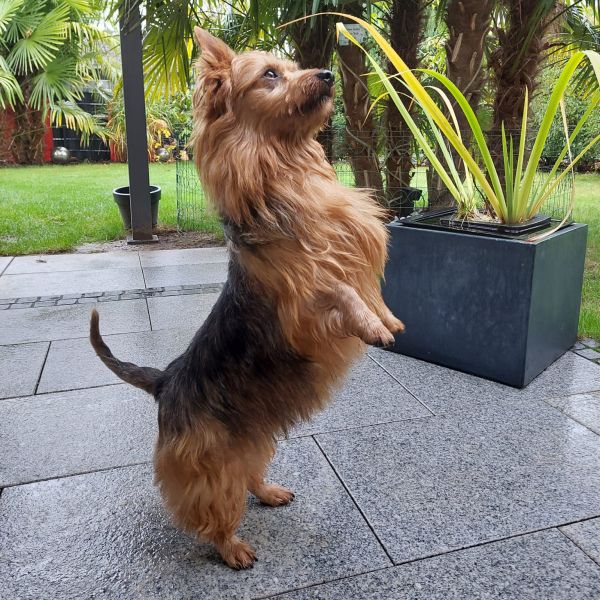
[316,401,600,563]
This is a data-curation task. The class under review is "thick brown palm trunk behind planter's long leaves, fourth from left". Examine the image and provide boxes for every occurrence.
[428,0,494,208]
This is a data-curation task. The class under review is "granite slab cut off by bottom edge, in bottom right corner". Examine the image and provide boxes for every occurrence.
[277,530,600,600]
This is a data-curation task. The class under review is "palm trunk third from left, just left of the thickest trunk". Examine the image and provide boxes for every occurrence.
[385,0,426,203]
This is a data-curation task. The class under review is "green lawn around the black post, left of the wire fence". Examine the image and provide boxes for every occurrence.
[0,163,212,255]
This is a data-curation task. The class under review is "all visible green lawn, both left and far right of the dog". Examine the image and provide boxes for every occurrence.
[0,163,600,339]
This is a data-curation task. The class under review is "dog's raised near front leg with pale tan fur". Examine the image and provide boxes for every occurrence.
[318,283,394,346]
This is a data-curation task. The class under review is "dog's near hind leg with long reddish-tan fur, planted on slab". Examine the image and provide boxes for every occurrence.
[155,438,256,569]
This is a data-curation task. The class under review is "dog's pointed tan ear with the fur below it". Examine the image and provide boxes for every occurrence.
[194,27,235,118]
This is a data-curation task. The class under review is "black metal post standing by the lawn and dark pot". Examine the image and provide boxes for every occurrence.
[120,0,158,244]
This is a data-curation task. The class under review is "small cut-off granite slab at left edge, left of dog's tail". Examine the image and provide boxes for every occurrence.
[0,342,50,398]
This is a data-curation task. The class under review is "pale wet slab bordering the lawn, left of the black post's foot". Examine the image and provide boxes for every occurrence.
[5,252,140,276]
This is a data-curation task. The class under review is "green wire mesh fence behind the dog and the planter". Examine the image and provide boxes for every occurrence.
[176,128,573,233]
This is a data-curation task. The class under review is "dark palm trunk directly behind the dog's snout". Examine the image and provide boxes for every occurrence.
[287,15,335,161]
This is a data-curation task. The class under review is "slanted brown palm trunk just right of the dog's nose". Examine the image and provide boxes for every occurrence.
[338,3,384,202]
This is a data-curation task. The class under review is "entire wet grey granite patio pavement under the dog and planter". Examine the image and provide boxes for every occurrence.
[0,248,600,600]
